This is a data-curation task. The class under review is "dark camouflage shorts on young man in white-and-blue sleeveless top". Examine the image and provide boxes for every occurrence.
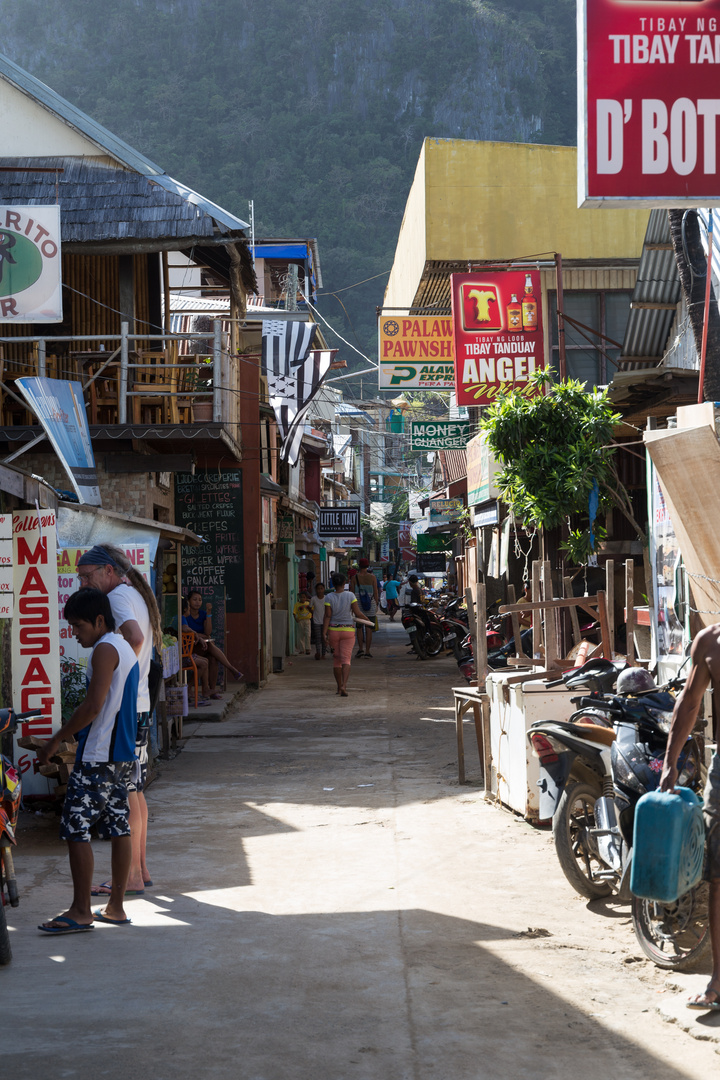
[60,761,133,843]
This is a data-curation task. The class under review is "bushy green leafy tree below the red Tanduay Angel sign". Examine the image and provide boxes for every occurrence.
[480,369,646,565]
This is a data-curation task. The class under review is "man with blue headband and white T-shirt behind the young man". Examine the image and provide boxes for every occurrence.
[78,544,162,896]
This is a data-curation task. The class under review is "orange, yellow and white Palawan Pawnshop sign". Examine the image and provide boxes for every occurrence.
[378,315,454,390]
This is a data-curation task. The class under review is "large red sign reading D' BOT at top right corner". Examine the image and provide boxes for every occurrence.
[578,0,720,207]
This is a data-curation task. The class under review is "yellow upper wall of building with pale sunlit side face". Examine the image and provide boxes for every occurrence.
[385,138,649,306]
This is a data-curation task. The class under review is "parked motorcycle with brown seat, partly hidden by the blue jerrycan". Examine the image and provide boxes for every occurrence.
[528,669,709,971]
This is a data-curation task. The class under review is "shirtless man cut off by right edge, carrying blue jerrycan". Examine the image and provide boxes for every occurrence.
[660,623,720,1012]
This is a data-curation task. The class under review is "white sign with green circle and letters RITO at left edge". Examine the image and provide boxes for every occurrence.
[0,206,63,323]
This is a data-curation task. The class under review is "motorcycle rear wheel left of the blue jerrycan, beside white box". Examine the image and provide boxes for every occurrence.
[553,783,612,900]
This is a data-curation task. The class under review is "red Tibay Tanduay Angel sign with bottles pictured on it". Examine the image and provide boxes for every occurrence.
[450,270,544,405]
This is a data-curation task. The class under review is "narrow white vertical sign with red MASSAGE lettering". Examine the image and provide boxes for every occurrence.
[12,510,62,795]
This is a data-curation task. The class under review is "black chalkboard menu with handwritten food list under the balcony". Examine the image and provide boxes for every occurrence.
[175,469,245,612]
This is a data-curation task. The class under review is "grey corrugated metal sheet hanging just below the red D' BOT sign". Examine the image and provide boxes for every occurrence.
[621,210,680,370]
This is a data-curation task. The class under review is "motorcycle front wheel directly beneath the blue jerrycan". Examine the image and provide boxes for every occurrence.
[631,881,710,971]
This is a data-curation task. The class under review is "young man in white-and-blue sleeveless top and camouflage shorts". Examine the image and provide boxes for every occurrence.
[38,589,139,934]
